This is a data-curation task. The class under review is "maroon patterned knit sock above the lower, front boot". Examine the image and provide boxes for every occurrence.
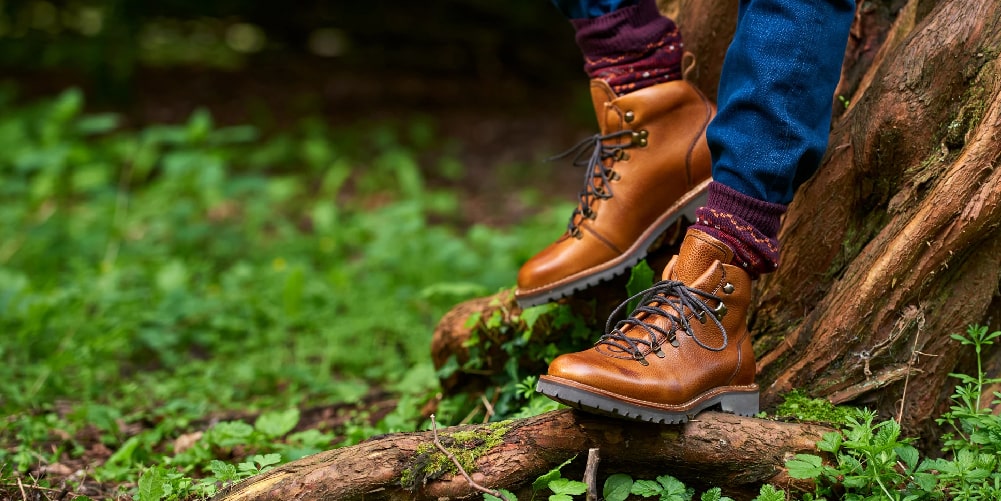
[692,181,786,278]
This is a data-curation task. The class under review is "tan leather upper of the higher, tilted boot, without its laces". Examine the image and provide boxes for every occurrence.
[516,80,716,301]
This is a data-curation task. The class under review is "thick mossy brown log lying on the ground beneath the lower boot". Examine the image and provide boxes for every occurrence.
[214,410,832,501]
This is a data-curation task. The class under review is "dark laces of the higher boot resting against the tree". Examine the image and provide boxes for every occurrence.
[550,129,634,236]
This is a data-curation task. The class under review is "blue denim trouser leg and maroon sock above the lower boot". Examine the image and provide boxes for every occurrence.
[695,0,855,276]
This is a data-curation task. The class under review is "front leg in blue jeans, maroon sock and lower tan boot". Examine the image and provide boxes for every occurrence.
[538,0,854,423]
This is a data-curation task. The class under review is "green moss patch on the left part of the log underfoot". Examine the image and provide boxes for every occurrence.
[399,421,511,489]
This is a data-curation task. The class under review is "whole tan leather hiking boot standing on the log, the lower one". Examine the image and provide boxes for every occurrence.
[536,229,758,423]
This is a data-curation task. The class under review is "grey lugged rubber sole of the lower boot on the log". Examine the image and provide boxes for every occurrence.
[536,376,759,424]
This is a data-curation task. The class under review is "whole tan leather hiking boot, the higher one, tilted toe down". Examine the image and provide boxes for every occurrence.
[515,80,716,308]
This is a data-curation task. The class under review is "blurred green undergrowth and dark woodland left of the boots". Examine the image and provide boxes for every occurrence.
[0,0,594,500]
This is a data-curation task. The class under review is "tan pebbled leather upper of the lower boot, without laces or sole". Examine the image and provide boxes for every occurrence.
[543,229,758,420]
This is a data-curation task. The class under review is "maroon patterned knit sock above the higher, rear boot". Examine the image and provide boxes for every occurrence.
[571,0,684,95]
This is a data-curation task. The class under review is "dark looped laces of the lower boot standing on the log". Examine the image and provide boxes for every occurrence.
[597,281,729,366]
